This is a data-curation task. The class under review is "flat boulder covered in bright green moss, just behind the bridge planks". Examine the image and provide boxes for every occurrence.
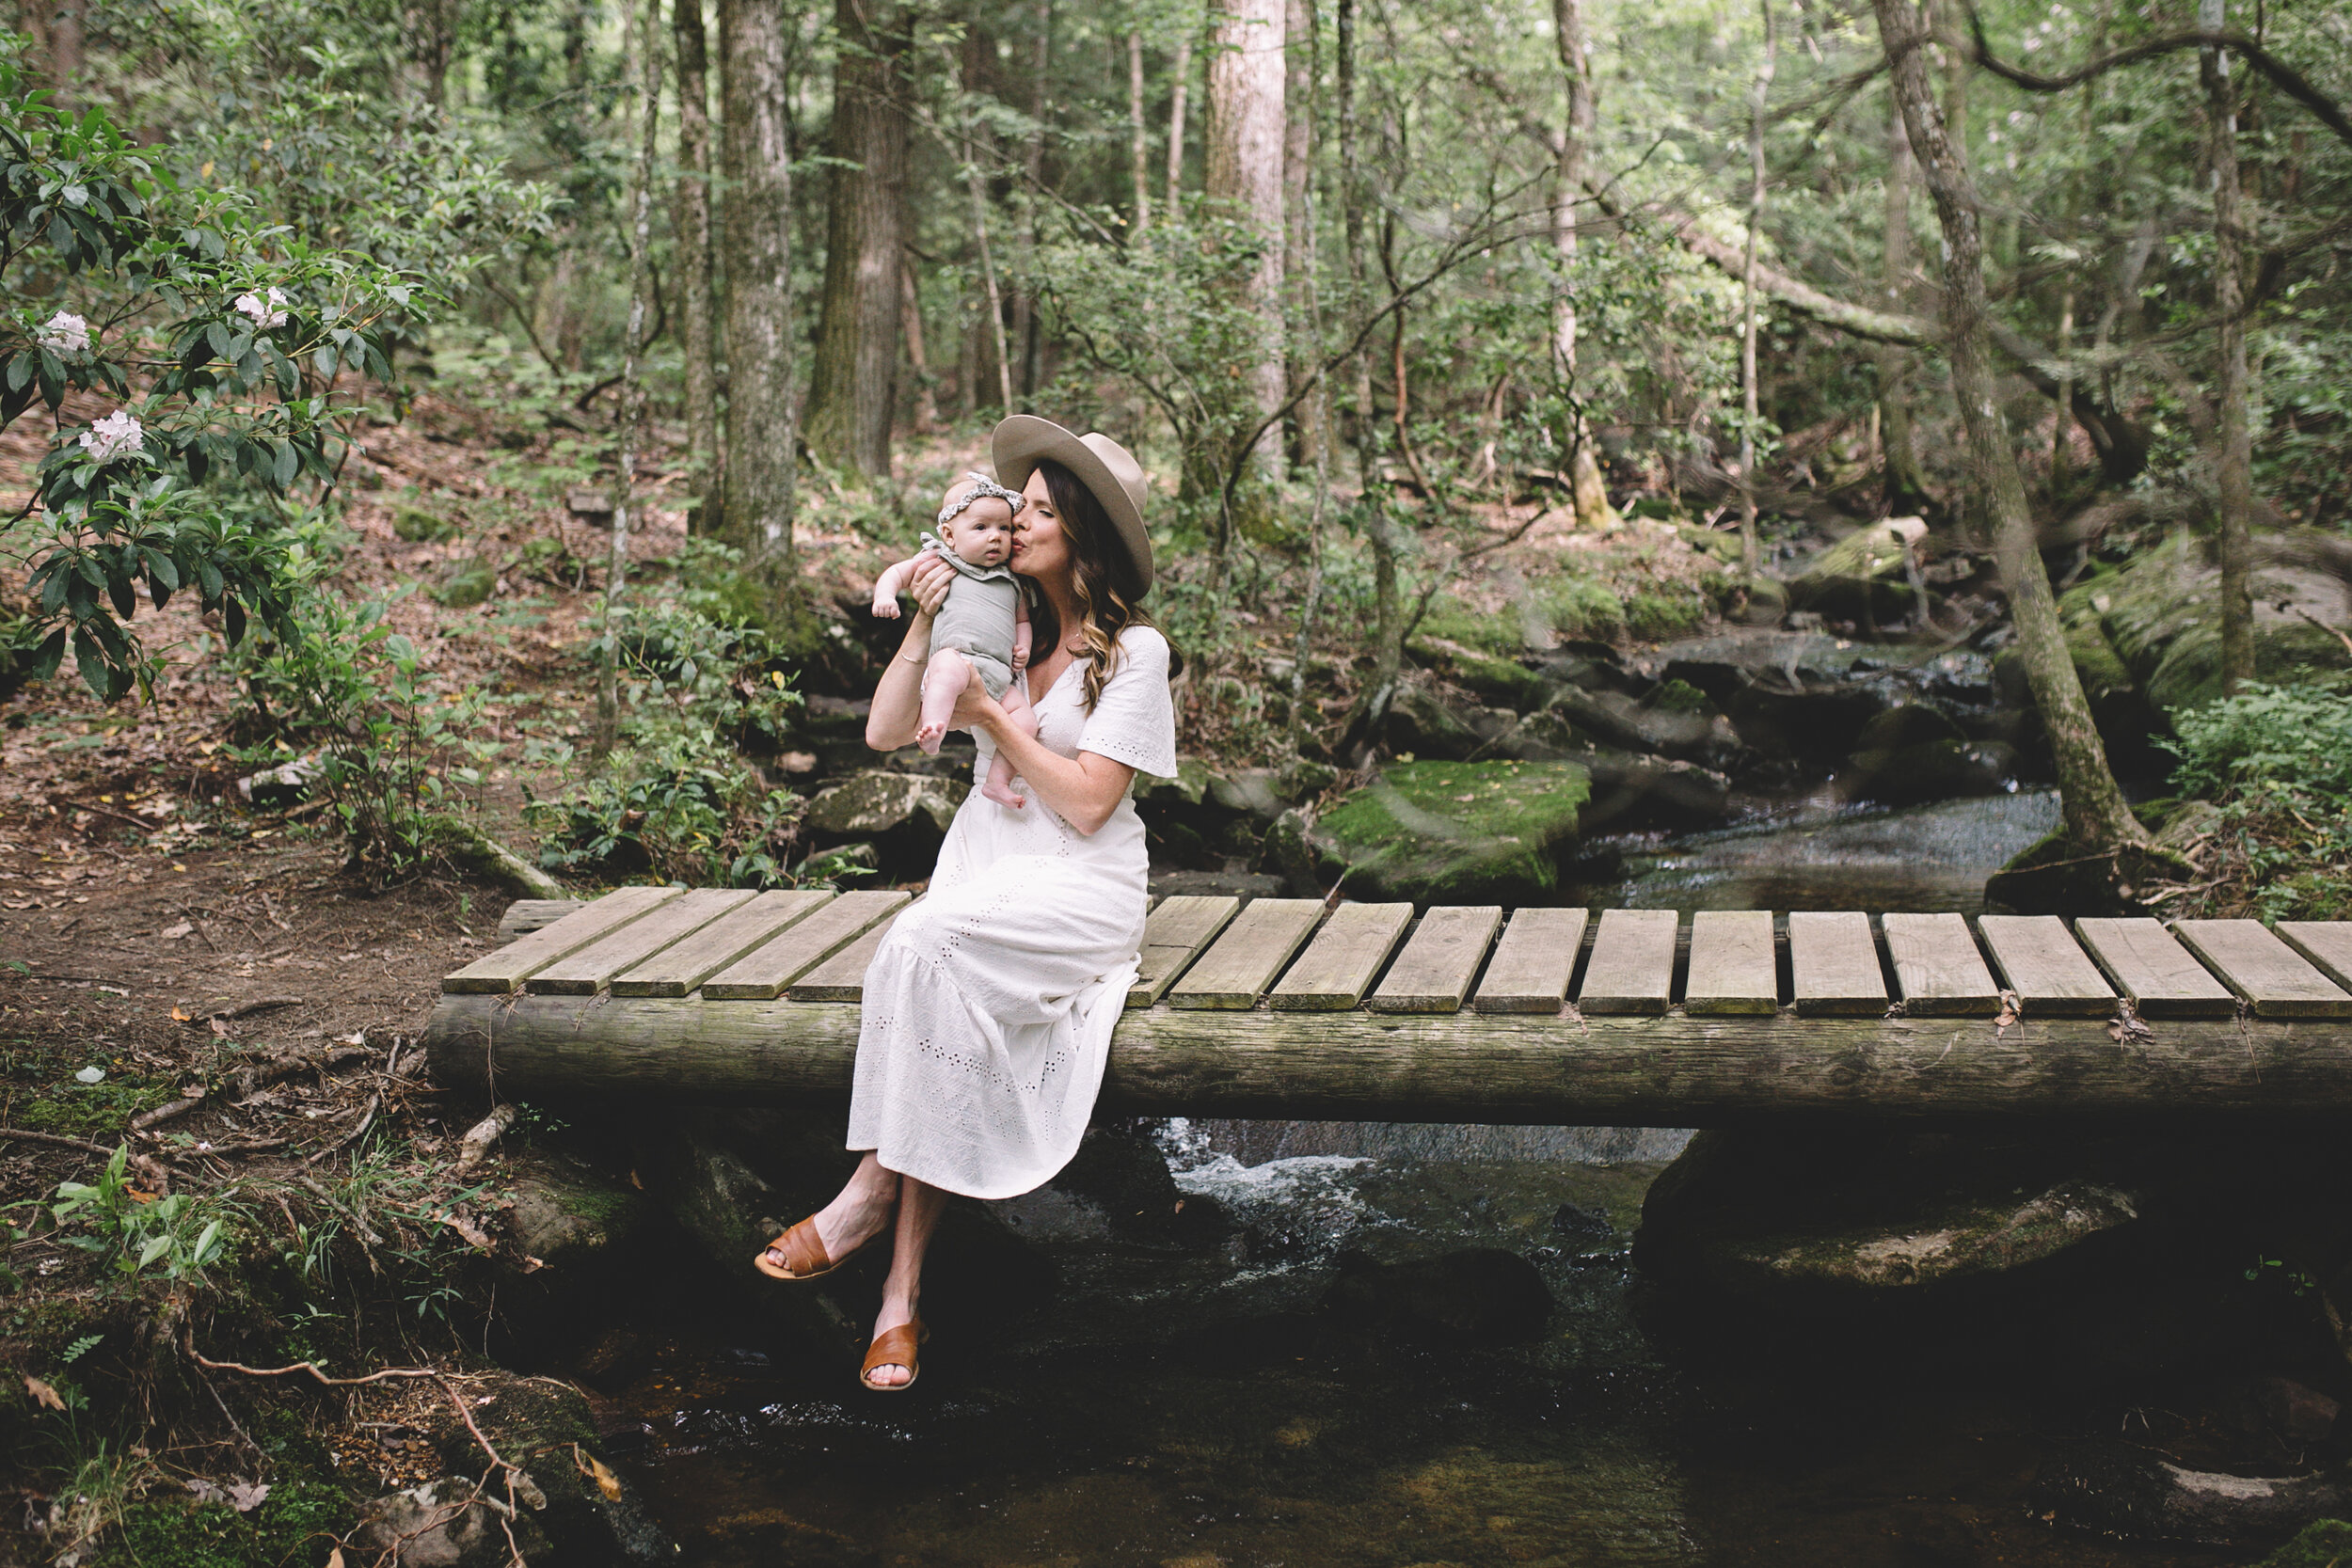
[1278,762,1593,905]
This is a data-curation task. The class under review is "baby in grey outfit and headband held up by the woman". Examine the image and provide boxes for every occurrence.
[875,472,1038,806]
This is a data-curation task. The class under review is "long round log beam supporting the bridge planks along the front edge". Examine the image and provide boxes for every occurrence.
[428,994,2352,1126]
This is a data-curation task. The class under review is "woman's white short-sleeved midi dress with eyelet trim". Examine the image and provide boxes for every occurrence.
[850,626,1176,1199]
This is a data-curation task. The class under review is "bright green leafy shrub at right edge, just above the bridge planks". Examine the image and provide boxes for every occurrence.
[2162,684,2352,919]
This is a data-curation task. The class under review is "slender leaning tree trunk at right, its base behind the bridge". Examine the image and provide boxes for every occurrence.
[1875,0,2148,872]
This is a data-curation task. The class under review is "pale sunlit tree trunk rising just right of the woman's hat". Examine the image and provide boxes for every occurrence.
[1207,0,1289,486]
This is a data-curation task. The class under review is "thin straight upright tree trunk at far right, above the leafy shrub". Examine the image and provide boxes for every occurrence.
[2197,0,2253,691]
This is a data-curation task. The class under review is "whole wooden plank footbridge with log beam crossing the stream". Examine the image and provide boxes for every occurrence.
[428,889,2352,1126]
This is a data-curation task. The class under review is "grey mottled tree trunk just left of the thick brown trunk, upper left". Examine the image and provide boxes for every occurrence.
[720,0,800,580]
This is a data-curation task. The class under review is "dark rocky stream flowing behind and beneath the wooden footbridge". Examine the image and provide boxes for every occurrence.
[605,792,2249,1568]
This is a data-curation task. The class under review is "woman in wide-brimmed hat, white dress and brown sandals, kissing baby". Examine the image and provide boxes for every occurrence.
[757,414,1176,1392]
